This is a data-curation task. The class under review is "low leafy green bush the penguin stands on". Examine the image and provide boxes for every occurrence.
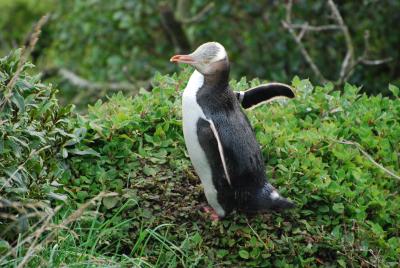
[64,67,400,266]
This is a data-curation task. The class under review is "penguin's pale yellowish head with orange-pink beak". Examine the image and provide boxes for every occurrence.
[170,42,229,75]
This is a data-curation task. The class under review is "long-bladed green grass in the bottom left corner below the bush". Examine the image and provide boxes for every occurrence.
[0,197,202,267]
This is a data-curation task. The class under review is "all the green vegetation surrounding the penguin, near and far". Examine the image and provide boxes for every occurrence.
[0,0,400,267]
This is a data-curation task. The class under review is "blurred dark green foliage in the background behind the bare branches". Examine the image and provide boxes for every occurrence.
[0,0,400,108]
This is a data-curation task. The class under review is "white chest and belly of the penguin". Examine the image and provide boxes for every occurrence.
[182,71,225,216]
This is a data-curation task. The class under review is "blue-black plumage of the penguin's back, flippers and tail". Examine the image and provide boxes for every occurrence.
[196,76,294,214]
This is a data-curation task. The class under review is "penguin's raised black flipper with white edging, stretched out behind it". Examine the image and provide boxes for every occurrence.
[235,83,295,109]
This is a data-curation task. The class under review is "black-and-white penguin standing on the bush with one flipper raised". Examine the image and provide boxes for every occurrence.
[170,42,295,220]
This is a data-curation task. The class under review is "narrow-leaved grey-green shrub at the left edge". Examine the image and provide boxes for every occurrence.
[0,50,88,244]
